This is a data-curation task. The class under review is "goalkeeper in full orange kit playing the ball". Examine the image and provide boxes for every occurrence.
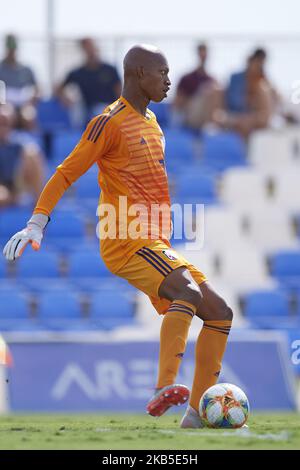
[4,45,232,428]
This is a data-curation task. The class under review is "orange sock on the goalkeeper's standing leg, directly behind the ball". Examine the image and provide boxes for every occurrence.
[190,320,231,411]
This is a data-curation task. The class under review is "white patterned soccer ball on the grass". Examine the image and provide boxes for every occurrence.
[199,384,250,428]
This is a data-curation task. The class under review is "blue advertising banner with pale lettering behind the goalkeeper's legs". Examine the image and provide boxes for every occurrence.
[9,333,295,412]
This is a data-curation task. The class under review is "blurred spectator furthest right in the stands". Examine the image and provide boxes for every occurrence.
[213,49,278,138]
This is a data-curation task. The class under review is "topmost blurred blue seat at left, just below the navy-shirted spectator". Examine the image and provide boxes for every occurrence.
[37,98,71,132]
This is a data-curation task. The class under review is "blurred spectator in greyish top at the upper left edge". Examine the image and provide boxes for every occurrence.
[0,34,39,130]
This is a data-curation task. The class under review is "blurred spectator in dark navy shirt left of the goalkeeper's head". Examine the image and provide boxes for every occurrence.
[57,38,121,120]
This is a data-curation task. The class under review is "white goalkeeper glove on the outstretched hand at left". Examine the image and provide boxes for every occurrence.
[3,214,50,261]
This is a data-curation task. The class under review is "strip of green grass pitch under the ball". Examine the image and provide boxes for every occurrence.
[0,413,300,450]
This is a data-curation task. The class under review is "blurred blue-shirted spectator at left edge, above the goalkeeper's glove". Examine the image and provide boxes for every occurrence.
[0,104,44,207]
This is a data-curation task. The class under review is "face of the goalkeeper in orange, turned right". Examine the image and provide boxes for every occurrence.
[140,54,171,103]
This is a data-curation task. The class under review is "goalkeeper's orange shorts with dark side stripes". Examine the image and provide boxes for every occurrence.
[116,240,207,314]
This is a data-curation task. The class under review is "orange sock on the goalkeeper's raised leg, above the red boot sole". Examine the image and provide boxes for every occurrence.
[157,300,196,388]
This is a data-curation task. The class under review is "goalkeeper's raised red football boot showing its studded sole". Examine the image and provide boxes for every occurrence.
[147,384,190,416]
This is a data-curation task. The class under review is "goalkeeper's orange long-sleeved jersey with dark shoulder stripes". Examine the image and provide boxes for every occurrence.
[34,97,170,273]
